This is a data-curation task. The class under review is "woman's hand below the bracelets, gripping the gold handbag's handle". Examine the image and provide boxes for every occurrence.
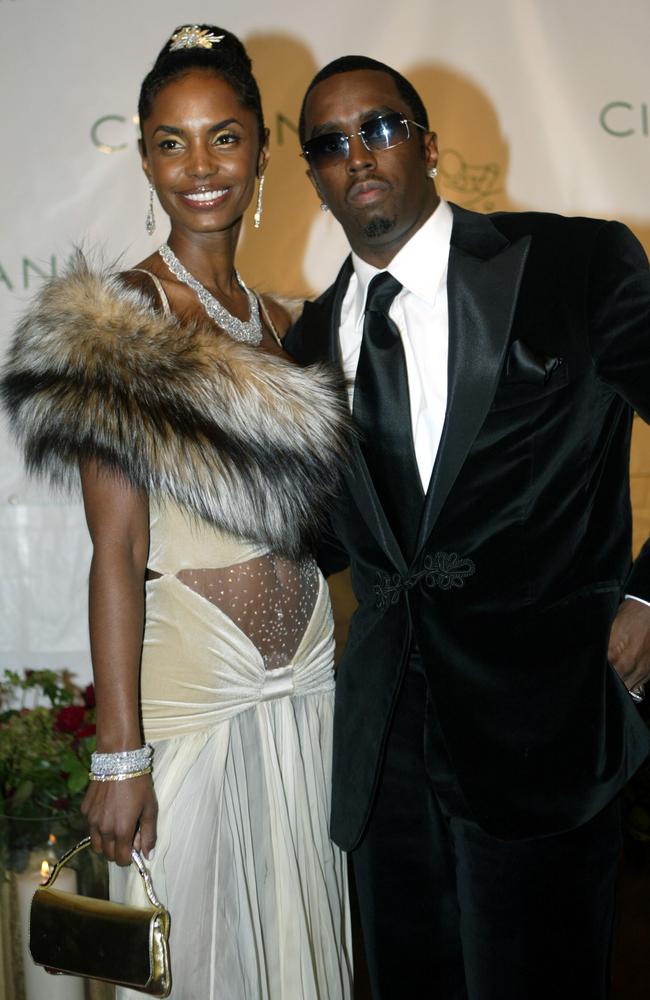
[81,774,158,865]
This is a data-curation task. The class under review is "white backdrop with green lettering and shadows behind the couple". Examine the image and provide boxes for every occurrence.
[0,0,650,677]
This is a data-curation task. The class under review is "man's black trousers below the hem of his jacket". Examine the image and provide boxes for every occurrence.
[352,656,621,1000]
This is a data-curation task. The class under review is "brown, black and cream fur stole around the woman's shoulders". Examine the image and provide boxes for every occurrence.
[0,255,349,558]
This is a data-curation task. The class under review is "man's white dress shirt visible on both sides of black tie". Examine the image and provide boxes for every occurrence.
[339,195,453,493]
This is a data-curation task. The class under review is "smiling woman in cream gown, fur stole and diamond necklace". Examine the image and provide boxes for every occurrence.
[4,25,350,1000]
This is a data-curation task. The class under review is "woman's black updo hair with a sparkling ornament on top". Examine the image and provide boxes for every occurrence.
[138,24,266,146]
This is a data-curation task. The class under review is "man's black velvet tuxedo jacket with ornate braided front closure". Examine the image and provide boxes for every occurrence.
[285,206,650,849]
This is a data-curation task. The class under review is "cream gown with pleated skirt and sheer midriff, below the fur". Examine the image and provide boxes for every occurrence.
[111,504,351,1000]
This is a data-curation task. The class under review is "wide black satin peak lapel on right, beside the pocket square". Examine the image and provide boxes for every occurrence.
[417,228,530,552]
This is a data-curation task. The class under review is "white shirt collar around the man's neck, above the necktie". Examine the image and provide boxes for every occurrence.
[352,198,453,317]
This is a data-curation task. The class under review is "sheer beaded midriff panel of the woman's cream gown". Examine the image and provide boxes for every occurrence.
[176,553,319,670]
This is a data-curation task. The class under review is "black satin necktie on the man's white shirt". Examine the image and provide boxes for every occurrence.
[352,271,424,560]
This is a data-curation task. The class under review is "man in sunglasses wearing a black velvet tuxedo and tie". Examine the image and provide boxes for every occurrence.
[286,56,650,1000]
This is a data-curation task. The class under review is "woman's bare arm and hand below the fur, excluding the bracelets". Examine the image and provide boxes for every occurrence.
[81,461,157,865]
